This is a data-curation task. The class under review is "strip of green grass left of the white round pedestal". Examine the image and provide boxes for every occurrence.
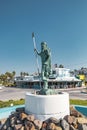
[0,99,25,108]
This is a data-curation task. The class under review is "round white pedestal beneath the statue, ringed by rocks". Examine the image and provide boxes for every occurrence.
[25,92,70,121]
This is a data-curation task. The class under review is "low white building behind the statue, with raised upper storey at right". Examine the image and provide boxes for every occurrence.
[14,68,81,88]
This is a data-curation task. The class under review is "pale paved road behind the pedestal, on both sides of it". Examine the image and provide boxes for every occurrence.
[0,87,87,101]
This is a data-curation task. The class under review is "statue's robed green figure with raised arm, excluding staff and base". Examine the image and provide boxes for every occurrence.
[35,42,51,80]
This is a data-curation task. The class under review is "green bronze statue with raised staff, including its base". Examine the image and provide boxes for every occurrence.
[32,33,55,95]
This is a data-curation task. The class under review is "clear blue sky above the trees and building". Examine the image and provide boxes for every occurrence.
[0,0,87,74]
